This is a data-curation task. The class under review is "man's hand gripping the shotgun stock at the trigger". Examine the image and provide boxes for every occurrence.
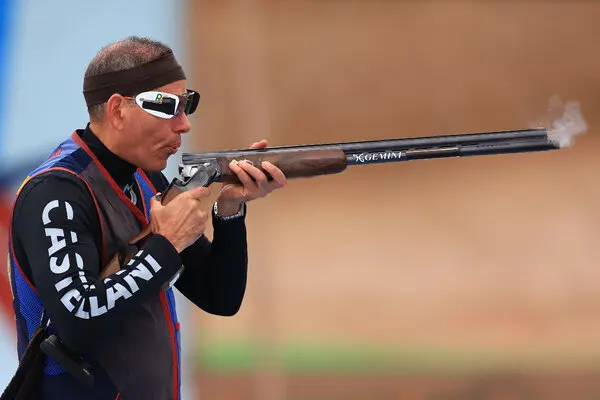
[150,187,210,253]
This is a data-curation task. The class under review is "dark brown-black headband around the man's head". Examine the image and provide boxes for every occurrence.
[83,53,185,107]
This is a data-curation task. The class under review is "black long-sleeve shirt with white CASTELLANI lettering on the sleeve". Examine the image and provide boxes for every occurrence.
[12,127,247,353]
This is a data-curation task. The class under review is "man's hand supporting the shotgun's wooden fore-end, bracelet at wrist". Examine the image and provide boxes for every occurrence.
[217,140,286,216]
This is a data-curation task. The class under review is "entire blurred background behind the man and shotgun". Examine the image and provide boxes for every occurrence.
[0,0,600,400]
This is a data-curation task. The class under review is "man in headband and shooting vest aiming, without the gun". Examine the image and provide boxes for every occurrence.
[9,37,286,400]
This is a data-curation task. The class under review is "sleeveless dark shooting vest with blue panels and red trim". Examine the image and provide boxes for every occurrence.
[9,132,181,400]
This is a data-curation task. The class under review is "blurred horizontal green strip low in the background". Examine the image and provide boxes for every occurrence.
[195,340,600,376]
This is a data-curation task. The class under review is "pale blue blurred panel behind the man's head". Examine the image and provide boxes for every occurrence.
[0,0,193,398]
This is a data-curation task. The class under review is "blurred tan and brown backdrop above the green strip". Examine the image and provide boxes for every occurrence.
[189,1,600,354]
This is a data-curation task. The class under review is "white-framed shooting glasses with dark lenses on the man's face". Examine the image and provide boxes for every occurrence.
[130,89,200,119]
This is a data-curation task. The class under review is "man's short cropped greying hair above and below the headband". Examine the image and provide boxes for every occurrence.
[84,36,173,121]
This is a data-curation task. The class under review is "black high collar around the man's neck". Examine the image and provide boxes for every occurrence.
[80,123,137,188]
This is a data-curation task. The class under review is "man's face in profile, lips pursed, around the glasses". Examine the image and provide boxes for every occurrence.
[119,80,191,172]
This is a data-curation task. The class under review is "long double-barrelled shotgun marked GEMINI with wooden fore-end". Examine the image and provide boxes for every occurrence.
[160,128,561,204]
